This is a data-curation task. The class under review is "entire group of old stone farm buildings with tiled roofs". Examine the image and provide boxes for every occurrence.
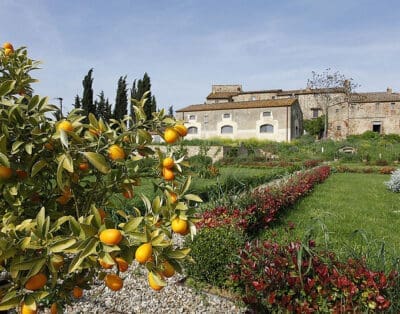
[177,85,400,141]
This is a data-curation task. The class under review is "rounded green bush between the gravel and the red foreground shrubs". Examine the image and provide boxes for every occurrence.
[184,227,245,287]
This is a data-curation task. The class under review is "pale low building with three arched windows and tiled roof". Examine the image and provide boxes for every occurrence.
[176,99,303,141]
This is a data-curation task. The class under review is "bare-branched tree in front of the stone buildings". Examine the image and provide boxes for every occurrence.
[307,68,359,139]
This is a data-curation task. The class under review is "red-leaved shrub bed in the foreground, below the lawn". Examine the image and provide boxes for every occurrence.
[232,241,399,313]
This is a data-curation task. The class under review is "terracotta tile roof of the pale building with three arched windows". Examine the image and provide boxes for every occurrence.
[176,98,297,112]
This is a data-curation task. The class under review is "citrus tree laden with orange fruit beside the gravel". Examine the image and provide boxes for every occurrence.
[0,43,201,313]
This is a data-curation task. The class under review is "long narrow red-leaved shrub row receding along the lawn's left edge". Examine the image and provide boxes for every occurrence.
[197,166,330,232]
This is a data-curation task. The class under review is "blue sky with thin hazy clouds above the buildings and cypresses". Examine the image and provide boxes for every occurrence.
[0,0,400,113]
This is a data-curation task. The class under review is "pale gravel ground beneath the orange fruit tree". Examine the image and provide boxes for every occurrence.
[66,263,245,314]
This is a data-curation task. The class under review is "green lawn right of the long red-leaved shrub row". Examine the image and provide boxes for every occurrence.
[262,173,400,269]
